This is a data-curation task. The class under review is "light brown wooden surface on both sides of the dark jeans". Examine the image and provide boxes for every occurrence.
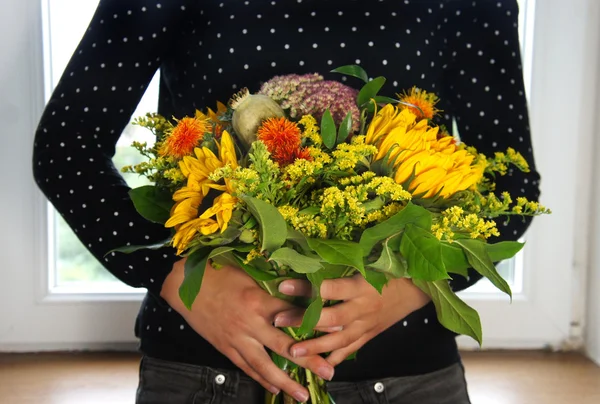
[0,352,600,404]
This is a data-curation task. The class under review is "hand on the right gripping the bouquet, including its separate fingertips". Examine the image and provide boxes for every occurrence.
[275,274,430,366]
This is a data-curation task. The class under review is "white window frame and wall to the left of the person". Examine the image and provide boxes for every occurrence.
[0,0,139,351]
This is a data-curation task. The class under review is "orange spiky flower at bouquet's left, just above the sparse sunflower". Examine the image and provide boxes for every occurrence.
[159,117,212,158]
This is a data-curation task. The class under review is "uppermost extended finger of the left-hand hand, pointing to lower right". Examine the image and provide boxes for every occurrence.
[257,326,334,380]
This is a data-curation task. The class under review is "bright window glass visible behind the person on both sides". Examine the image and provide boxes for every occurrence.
[42,0,534,293]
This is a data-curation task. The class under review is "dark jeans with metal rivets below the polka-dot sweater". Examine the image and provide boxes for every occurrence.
[136,357,470,404]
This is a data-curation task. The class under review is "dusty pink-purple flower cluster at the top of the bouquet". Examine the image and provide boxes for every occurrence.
[258,73,360,132]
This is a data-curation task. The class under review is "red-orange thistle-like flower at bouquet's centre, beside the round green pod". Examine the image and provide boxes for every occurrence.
[257,118,310,165]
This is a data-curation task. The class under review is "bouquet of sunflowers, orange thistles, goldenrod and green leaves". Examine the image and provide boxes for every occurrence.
[121,65,549,404]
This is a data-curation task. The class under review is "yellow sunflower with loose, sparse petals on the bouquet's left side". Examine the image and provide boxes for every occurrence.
[165,131,238,254]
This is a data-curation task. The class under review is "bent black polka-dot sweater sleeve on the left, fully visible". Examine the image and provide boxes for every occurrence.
[33,0,186,296]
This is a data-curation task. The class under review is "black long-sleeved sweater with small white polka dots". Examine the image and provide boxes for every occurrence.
[33,0,539,380]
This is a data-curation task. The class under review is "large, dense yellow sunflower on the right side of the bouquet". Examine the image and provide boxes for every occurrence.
[367,105,485,198]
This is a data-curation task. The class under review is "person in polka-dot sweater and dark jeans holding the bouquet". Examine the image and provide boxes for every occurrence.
[34,0,539,404]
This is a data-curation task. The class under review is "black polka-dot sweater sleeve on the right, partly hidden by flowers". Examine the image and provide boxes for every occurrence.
[443,0,540,290]
